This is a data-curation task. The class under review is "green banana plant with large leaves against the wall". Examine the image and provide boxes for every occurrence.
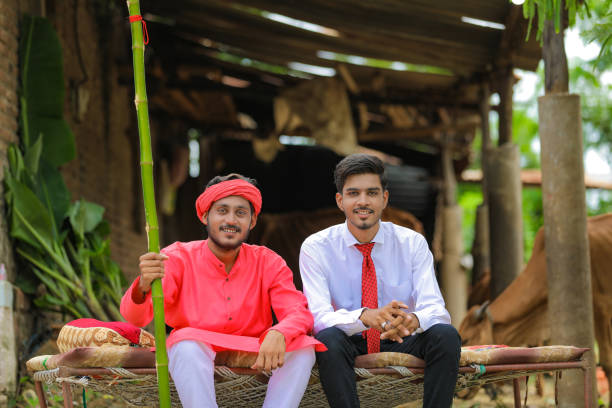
[4,16,125,320]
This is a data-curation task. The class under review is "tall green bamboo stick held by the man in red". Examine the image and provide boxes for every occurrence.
[127,0,170,408]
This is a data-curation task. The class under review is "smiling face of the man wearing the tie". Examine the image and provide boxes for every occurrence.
[336,173,389,242]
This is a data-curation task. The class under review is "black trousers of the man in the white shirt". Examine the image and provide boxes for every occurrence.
[315,324,461,408]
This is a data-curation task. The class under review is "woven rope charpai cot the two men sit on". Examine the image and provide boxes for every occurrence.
[28,346,588,408]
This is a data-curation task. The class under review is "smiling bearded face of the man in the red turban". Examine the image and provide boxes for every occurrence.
[202,196,257,252]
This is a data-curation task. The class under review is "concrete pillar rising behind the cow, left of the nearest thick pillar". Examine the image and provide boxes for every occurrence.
[487,143,523,299]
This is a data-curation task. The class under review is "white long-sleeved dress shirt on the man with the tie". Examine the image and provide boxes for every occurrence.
[300,222,450,336]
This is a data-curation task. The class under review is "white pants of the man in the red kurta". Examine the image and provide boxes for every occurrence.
[168,340,315,408]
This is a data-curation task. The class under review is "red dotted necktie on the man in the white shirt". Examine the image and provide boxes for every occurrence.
[355,242,380,354]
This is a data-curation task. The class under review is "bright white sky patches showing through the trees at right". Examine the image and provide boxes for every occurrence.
[514,27,612,180]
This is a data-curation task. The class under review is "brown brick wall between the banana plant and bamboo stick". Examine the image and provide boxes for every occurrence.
[48,1,147,281]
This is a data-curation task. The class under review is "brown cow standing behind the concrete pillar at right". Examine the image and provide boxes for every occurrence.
[459,214,612,399]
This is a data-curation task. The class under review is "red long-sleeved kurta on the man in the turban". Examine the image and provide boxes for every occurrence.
[121,240,326,352]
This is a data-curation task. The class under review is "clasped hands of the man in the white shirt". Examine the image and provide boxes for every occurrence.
[360,300,420,343]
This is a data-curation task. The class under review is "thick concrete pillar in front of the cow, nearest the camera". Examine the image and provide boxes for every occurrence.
[538,93,597,407]
